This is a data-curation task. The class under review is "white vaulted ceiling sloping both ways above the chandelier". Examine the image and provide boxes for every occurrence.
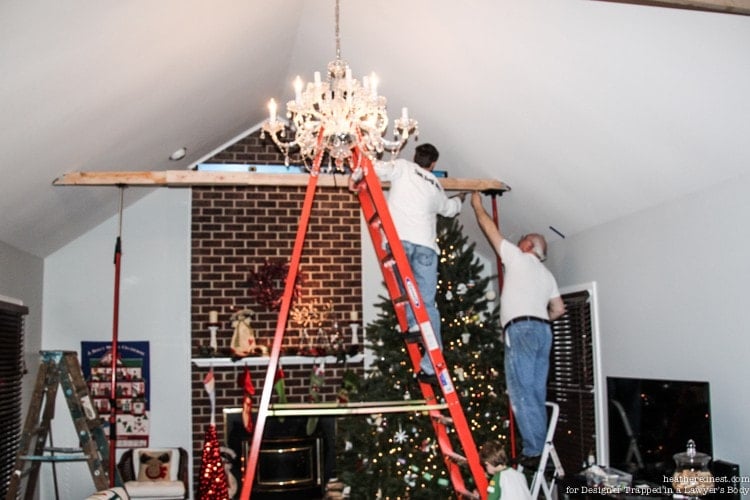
[0,0,750,257]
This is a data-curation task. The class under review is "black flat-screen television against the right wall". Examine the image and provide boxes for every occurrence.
[607,377,713,484]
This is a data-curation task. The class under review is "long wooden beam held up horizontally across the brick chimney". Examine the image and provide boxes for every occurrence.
[52,170,510,192]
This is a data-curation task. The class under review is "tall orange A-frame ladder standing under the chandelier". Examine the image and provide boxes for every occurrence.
[240,139,488,500]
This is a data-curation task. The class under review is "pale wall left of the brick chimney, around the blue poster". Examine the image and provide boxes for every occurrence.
[41,189,192,498]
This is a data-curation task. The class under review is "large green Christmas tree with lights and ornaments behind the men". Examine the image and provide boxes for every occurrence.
[337,218,508,500]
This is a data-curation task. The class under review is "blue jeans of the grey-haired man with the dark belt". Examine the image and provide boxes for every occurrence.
[505,321,552,457]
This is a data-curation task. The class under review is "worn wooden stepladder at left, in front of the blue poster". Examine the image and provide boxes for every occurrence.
[5,351,122,500]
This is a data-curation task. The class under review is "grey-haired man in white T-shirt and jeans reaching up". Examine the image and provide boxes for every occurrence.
[471,192,565,468]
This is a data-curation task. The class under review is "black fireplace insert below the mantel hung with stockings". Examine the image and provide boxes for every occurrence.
[224,408,336,500]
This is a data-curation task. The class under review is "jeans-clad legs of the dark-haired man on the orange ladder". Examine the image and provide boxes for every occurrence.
[401,240,443,374]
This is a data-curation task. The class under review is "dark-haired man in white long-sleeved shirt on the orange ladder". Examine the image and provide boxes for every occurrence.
[362,144,464,382]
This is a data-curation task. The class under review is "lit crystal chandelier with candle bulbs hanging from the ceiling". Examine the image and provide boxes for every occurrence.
[261,0,419,171]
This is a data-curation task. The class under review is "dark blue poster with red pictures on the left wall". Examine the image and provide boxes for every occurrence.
[81,341,151,448]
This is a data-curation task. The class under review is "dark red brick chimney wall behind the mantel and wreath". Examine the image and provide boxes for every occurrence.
[191,134,369,494]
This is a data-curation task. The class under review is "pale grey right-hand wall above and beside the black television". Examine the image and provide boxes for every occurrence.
[548,172,750,480]
